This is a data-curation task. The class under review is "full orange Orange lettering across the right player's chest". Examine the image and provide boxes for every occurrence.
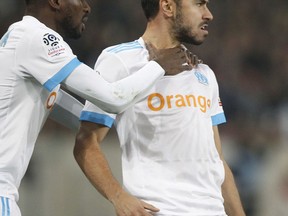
[147,93,211,113]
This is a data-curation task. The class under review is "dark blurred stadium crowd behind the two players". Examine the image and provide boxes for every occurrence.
[0,0,288,216]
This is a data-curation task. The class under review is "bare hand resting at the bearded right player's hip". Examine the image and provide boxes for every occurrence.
[111,192,159,216]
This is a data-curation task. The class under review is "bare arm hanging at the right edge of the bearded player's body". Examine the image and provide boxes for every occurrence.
[213,126,245,216]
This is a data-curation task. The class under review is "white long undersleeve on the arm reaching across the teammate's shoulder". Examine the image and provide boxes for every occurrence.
[62,61,164,113]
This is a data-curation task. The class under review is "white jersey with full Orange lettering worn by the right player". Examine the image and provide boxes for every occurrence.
[81,38,226,216]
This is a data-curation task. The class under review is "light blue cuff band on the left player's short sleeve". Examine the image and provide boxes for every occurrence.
[43,58,81,92]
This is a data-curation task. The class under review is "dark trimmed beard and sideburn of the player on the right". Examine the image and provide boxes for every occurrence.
[171,8,203,45]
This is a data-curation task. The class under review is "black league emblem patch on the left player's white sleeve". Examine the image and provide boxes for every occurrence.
[43,33,65,57]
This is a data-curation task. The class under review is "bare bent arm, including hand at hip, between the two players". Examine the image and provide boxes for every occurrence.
[74,121,158,216]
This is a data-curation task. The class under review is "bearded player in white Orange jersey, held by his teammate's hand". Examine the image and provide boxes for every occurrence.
[74,0,245,216]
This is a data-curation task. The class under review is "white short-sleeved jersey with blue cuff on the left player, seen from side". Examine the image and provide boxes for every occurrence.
[0,16,81,201]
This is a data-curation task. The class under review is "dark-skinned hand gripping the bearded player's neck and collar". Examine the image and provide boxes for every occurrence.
[146,43,202,75]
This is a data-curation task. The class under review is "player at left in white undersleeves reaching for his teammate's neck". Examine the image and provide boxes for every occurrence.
[0,0,190,216]
